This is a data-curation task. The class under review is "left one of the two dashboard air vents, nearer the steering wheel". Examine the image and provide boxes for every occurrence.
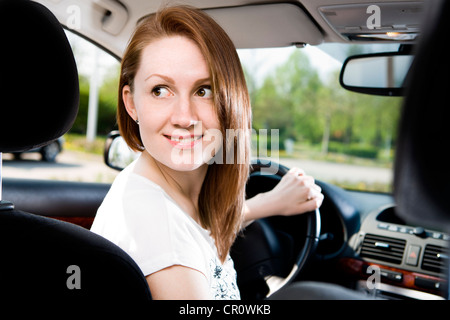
[360,234,406,264]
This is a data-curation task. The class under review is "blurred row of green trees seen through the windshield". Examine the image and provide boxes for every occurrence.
[246,48,401,158]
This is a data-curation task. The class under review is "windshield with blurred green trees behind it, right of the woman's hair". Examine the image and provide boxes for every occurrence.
[239,46,402,192]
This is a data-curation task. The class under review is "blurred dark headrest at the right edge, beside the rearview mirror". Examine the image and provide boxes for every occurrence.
[394,0,450,230]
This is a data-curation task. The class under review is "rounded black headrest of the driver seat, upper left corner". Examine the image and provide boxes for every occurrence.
[0,0,79,152]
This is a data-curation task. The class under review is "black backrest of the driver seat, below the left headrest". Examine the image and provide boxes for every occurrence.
[0,210,150,301]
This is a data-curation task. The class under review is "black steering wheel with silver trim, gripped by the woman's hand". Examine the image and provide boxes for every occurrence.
[231,159,321,299]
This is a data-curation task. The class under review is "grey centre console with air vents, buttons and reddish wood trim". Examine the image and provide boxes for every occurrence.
[346,205,450,299]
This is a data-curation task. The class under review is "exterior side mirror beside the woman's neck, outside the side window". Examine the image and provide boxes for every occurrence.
[104,131,140,171]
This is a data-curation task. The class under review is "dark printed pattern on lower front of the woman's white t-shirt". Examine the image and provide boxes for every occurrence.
[209,256,241,300]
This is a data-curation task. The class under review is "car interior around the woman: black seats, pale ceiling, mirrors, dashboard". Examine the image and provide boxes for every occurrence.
[0,0,450,300]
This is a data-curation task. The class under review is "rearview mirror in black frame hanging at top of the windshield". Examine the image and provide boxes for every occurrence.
[339,52,413,96]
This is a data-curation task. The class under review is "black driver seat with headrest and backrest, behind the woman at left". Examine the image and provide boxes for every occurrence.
[0,0,151,301]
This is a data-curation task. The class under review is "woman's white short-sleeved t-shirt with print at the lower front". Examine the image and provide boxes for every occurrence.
[91,161,240,299]
